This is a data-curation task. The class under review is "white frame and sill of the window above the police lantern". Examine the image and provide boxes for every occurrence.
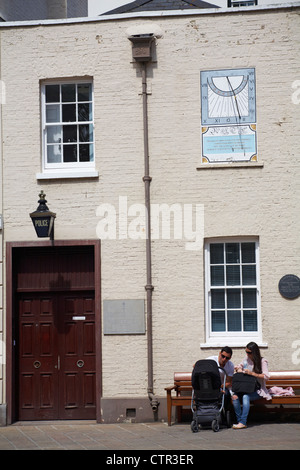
[36,77,98,179]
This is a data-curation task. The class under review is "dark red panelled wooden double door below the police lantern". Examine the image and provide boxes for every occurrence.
[17,291,96,420]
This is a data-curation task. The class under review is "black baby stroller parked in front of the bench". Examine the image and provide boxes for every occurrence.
[191,359,230,432]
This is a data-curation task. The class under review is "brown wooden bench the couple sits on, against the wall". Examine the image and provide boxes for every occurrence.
[165,370,300,426]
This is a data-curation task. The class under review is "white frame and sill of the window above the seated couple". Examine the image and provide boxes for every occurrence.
[201,237,266,347]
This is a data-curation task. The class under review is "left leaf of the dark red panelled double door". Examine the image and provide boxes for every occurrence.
[19,294,58,420]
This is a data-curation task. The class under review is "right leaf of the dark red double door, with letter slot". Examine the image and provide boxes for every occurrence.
[59,293,96,419]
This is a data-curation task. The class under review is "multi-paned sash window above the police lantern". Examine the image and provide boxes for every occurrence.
[42,81,94,176]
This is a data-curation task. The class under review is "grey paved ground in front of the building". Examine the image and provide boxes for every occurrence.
[0,421,300,452]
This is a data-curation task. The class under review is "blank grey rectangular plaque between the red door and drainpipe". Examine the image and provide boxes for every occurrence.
[103,300,146,335]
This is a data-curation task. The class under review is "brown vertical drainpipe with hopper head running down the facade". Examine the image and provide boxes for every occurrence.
[129,34,159,413]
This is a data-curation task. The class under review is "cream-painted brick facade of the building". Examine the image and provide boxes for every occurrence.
[0,7,300,418]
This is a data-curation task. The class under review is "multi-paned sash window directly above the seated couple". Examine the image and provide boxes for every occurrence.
[206,240,260,343]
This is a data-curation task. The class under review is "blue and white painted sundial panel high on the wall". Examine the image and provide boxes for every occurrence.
[200,68,257,163]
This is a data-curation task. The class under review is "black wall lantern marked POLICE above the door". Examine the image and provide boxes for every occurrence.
[29,191,56,240]
